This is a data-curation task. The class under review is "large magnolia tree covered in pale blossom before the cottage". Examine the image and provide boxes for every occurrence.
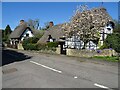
[63,5,112,48]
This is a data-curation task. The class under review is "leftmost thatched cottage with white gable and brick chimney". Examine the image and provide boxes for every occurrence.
[9,20,37,45]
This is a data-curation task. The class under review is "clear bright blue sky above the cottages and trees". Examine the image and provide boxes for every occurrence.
[0,2,118,29]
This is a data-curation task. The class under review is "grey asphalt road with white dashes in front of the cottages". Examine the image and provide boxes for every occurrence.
[2,49,118,90]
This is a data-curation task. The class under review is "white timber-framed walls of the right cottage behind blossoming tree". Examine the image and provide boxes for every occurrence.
[65,25,113,50]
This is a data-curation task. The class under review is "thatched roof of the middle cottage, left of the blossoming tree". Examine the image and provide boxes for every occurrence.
[38,24,65,43]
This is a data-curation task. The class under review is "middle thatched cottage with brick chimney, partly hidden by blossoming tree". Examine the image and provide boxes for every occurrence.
[38,22,66,54]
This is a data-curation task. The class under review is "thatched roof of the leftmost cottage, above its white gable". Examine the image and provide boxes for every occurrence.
[10,23,38,38]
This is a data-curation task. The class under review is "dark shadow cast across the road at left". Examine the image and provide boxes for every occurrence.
[2,49,32,66]
